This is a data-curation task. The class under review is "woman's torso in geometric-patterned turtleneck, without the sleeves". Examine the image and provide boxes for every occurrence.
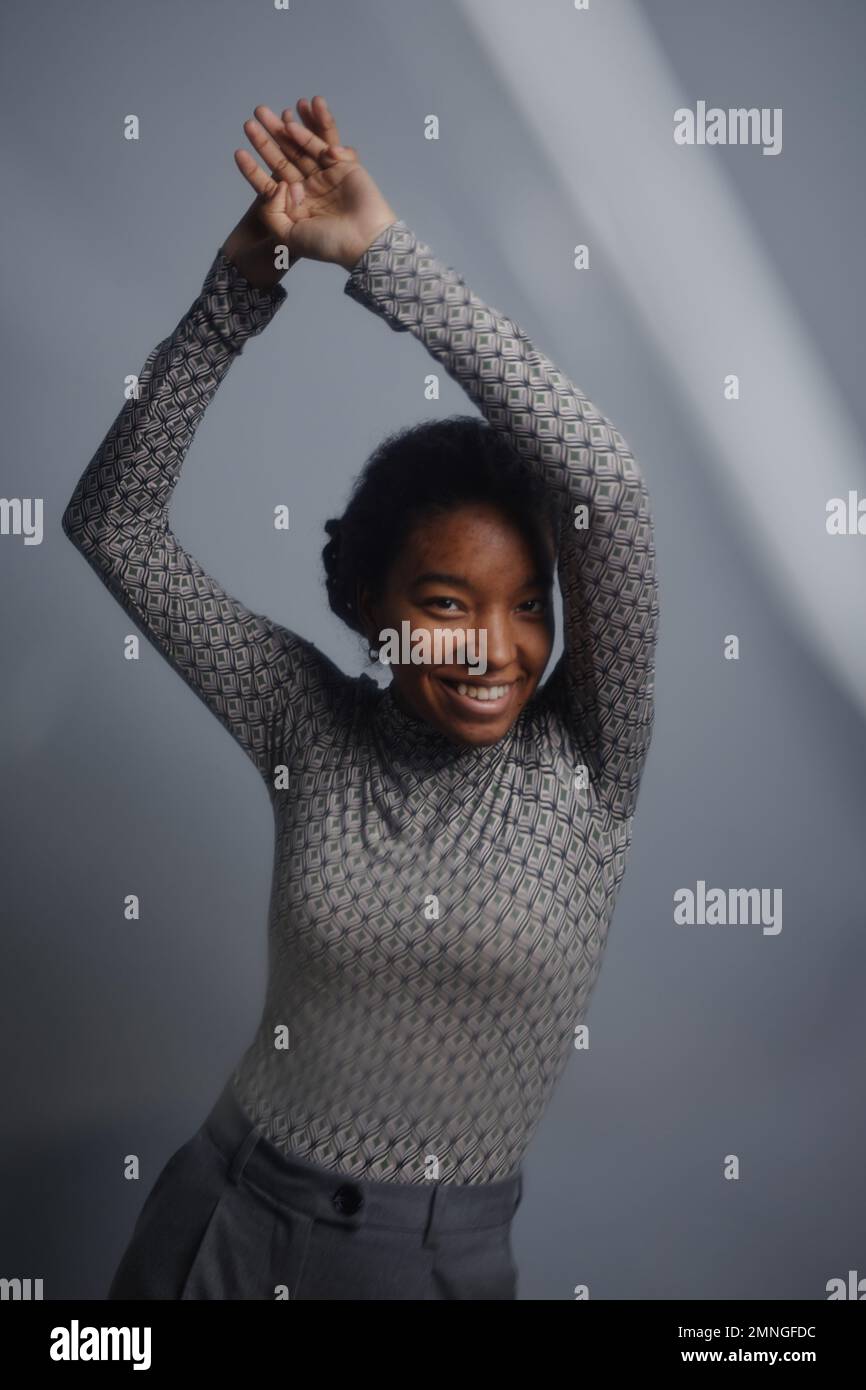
[234,678,631,1182]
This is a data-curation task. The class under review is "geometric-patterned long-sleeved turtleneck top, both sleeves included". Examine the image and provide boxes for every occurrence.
[63,220,657,1183]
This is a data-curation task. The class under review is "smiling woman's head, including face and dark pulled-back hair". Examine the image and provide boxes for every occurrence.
[322,416,559,744]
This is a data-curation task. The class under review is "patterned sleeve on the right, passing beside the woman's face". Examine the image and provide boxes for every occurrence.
[343,218,659,819]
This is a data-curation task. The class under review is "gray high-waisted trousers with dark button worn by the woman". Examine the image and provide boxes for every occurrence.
[107,1080,523,1301]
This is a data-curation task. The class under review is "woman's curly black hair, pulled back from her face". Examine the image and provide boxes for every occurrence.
[321,416,559,656]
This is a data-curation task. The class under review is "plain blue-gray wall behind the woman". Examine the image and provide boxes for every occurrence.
[0,0,866,1300]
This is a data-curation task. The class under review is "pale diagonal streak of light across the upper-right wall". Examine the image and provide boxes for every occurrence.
[456,0,866,712]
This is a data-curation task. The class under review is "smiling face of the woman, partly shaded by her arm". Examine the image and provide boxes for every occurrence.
[360,503,555,745]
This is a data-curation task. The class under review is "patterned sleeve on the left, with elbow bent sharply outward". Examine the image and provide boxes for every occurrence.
[63,250,324,780]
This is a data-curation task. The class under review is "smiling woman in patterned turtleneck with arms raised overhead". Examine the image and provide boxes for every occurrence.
[64,97,657,1300]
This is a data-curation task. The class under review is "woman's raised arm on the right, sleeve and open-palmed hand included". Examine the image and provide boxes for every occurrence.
[222,97,659,819]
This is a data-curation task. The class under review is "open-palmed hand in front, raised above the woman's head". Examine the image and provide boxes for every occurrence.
[224,96,398,278]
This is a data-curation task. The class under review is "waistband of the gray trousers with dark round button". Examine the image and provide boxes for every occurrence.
[202,1079,523,1244]
